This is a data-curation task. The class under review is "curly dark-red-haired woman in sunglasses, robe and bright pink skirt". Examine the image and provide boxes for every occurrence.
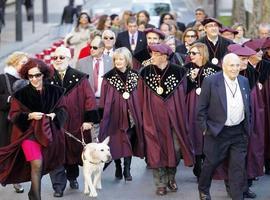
[0,58,66,200]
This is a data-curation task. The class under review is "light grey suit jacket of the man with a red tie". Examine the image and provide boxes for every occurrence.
[77,54,113,88]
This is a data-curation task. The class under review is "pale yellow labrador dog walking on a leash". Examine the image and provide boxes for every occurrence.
[82,137,112,197]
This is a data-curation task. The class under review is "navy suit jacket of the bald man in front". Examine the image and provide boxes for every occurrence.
[197,72,250,136]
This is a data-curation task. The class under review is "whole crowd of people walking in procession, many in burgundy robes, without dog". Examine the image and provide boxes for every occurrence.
[0,3,270,200]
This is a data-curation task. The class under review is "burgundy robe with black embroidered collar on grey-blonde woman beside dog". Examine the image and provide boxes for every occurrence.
[99,68,144,160]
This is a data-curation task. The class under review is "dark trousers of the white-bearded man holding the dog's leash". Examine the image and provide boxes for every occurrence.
[50,165,79,191]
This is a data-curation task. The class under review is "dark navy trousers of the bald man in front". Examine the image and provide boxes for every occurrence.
[198,124,248,200]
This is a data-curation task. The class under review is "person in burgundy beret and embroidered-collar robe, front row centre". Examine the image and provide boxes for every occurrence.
[139,44,193,195]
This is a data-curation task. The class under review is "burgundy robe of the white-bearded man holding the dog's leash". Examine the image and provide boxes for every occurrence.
[49,67,99,165]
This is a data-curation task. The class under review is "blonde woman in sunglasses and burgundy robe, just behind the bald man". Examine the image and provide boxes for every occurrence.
[184,43,221,178]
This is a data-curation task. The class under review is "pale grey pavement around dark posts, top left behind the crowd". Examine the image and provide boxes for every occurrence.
[0,0,67,73]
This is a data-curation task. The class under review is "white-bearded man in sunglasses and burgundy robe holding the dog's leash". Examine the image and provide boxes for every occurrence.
[49,47,99,197]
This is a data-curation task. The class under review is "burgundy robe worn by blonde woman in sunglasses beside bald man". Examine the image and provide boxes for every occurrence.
[184,62,221,155]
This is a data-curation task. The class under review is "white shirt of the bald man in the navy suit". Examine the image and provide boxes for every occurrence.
[223,73,245,126]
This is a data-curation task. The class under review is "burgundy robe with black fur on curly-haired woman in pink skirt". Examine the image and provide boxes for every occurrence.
[0,84,67,184]
